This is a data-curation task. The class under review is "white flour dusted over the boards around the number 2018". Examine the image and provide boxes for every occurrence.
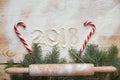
[4,0,120,60]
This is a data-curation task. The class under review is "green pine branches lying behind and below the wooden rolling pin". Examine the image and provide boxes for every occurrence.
[6,44,120,80]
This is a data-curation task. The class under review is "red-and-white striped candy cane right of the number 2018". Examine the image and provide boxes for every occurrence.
[80,21,96,53]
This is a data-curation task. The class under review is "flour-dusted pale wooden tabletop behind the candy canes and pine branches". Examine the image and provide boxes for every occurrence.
[0,0,120,79]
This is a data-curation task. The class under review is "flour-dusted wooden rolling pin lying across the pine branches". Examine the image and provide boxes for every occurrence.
[6,64,117,76]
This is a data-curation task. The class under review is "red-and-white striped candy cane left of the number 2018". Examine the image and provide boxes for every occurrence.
[14,22,32,54]
